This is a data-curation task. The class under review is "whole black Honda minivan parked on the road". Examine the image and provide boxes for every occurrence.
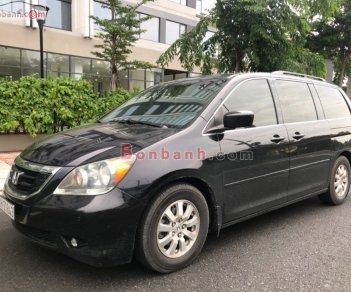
[0,72,351,273]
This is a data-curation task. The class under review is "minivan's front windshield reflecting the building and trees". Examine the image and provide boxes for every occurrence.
[100,77,228,128]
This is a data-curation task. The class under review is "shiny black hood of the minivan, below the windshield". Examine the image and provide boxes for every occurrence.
[21,123,179,166]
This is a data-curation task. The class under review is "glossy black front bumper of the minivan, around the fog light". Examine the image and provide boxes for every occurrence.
[5,188,144,267]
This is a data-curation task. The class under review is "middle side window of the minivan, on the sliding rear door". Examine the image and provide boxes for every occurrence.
[276,80,317,123]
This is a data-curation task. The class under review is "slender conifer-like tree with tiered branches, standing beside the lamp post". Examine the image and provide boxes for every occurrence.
[91,0,153,90]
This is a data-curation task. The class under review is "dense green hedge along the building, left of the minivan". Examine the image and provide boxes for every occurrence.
[0,76,131,136]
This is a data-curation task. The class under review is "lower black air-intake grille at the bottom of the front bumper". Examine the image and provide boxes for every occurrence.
[13,222,58,248]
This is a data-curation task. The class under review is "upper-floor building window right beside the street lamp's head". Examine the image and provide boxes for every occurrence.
[39,0,72,30]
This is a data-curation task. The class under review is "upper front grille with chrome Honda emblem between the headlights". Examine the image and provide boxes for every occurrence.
[8,165,51,196]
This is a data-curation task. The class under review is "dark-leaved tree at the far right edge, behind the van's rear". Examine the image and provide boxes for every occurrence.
[310,0,351,86]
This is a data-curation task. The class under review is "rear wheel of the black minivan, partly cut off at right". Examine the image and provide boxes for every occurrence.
[319,156,351,206]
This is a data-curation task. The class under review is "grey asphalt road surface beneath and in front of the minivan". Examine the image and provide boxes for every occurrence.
[0,197,351,292]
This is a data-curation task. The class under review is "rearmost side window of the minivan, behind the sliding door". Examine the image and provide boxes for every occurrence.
[316,85,350,119]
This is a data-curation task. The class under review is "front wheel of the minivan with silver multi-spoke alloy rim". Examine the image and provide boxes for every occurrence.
[136,184,209,273]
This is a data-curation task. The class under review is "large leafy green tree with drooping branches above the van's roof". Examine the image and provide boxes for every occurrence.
[158,0,335,76]
